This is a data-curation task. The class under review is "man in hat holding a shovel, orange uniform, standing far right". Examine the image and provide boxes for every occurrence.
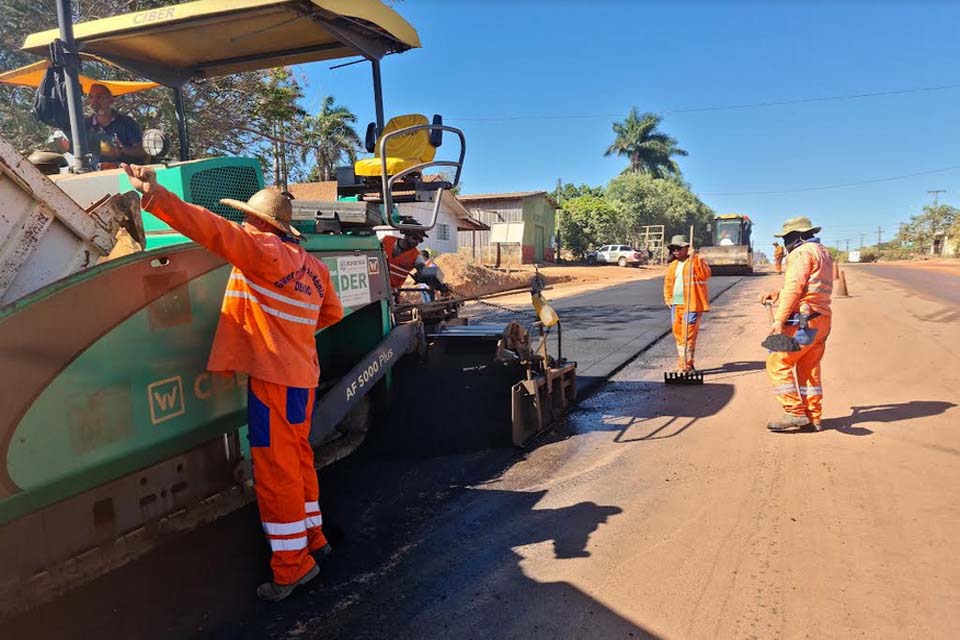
[760,217,833,431]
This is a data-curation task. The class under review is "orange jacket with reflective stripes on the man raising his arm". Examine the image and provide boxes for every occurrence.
[143,187,343,389]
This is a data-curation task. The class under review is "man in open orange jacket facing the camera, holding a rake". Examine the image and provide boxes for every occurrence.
[663,235,711,372]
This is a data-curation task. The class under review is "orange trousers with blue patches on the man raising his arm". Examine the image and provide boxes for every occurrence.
[247,378,327,584]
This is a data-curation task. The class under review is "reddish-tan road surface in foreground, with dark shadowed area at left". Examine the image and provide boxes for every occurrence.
[0,269,960,640]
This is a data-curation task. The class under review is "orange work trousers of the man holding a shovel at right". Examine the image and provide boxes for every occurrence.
[767,316,831,424]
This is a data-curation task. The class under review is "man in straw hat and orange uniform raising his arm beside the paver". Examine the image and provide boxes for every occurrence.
[123,164,343,601]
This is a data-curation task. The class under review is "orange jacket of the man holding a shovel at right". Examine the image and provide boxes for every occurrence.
[775,241,833,322]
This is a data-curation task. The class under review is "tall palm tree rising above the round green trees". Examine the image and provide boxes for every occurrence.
[603,107,687,178]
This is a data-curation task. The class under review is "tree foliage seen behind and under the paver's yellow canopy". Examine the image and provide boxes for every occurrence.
[0,0,359,182]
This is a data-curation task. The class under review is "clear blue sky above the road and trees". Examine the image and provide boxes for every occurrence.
[299,0,960,248]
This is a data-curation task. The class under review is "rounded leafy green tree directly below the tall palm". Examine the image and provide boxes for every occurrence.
[607,173,713,245]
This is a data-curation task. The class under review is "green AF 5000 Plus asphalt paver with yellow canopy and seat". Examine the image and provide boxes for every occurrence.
[0,0,575,618]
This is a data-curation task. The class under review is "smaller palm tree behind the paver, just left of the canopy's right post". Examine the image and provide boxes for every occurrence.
[302,96,360,182]
